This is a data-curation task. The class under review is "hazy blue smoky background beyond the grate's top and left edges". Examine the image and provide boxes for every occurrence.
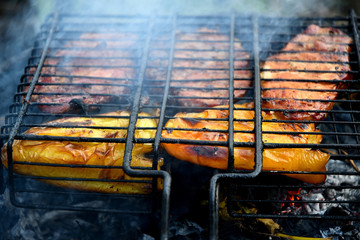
[0,0,360,118]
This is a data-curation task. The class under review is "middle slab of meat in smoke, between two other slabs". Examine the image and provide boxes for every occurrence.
[147,28,252,107]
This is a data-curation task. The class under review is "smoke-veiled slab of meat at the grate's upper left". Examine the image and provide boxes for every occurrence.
[30,33,136,113]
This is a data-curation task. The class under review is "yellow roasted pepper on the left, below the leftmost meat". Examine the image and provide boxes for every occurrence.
[1,111,162,194]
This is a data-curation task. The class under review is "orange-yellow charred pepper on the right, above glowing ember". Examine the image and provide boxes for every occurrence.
[162,103,329,183]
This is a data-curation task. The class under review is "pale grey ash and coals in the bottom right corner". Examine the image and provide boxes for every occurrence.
[282,160,360,240]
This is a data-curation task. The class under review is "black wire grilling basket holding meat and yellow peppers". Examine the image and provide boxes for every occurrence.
[1,8,360,239]
